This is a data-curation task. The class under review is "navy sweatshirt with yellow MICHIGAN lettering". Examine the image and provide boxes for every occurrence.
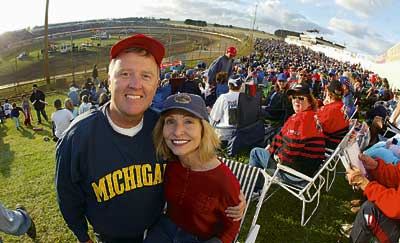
[55,104,165,242]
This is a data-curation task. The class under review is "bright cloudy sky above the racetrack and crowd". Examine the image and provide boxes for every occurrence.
[0,0,400,55]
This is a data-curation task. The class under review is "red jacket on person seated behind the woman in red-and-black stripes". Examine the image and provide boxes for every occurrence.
[317,101,349,149]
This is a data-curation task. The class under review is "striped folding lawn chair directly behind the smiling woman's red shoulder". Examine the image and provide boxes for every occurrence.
[219,158,267,243]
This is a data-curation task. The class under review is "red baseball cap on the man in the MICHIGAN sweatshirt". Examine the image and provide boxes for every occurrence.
[110,34,165,65]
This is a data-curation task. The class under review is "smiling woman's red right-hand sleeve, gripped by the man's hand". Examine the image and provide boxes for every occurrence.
[218,175,240,243]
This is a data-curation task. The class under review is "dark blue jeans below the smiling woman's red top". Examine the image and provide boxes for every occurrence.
[143,216,222,243]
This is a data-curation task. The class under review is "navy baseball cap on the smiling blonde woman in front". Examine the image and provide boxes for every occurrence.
[161,93,208,121]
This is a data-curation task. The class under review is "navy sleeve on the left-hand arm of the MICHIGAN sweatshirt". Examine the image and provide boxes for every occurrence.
[55,130,90,242]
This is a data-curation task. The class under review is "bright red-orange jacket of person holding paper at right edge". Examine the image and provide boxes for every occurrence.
[364,159,400,219]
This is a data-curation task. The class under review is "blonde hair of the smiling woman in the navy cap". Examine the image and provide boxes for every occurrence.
[153,112,221,162]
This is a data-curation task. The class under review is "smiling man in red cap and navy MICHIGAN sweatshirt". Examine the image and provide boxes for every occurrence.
[55,34,243,243]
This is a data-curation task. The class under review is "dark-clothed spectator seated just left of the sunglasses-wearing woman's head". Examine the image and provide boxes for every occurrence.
[265,73,294,124]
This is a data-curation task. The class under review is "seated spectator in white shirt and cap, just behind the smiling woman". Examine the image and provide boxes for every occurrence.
[210,75,243,141]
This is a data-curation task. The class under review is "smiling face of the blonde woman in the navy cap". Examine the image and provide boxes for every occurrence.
[163,110,202,159]
